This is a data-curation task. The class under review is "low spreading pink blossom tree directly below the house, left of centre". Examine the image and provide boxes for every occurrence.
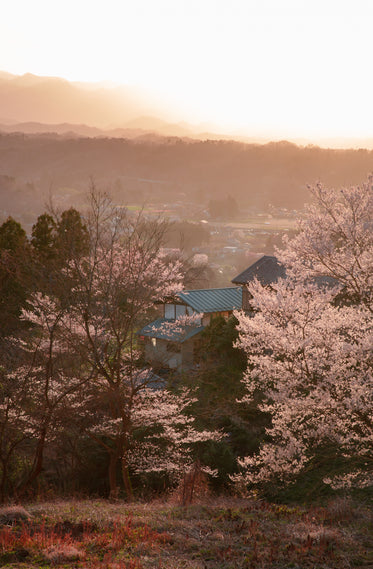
[90,382,222,496]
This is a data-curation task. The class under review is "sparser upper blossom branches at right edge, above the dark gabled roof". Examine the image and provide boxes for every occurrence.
[280,177,373,312]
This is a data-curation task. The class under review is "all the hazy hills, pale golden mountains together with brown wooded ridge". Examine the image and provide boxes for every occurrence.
[0,67,373,223]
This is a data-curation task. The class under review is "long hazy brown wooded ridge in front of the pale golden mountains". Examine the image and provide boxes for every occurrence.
[0,134,373,215]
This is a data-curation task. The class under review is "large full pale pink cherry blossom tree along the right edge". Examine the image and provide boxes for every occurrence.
[237,179,373,487]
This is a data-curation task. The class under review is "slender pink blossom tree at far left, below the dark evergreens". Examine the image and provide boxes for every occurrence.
[12,293,90,493]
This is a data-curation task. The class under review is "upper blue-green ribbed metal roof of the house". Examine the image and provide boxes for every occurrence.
[177,287,242,313]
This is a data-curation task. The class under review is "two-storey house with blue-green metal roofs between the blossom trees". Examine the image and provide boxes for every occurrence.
[138,286,242,371]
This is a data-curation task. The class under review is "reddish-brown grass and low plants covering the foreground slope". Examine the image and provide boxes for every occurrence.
[0,498,373,569]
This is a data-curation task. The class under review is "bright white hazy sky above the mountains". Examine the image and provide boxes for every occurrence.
[0,0,373,139]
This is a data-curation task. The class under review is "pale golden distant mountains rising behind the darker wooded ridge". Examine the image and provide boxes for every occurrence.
[0,71,373,148]
